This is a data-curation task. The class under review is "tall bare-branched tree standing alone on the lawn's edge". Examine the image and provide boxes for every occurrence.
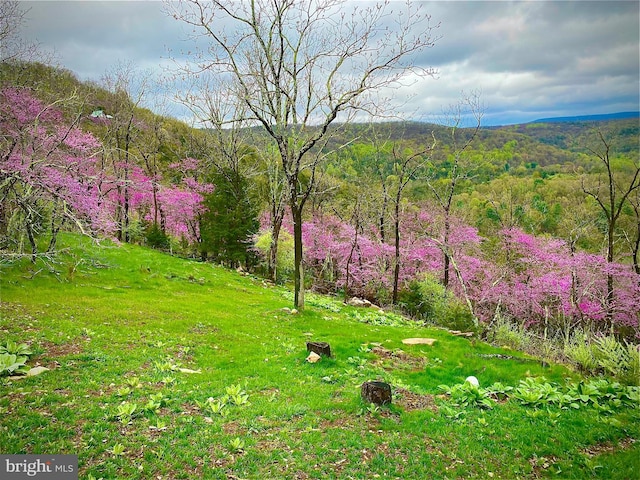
[167,0,434,309]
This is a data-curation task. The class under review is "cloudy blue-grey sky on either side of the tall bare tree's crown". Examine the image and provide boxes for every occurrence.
[13,0,640,126]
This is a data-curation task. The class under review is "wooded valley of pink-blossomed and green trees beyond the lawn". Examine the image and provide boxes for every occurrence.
[0,62,640,352]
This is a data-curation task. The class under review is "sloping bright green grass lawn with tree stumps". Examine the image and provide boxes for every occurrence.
[0,235,640,479]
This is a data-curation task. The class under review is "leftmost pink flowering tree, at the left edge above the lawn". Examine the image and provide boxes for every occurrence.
[0,88,114,261]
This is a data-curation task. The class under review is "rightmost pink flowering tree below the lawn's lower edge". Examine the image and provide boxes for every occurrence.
[483,228,640,338]
